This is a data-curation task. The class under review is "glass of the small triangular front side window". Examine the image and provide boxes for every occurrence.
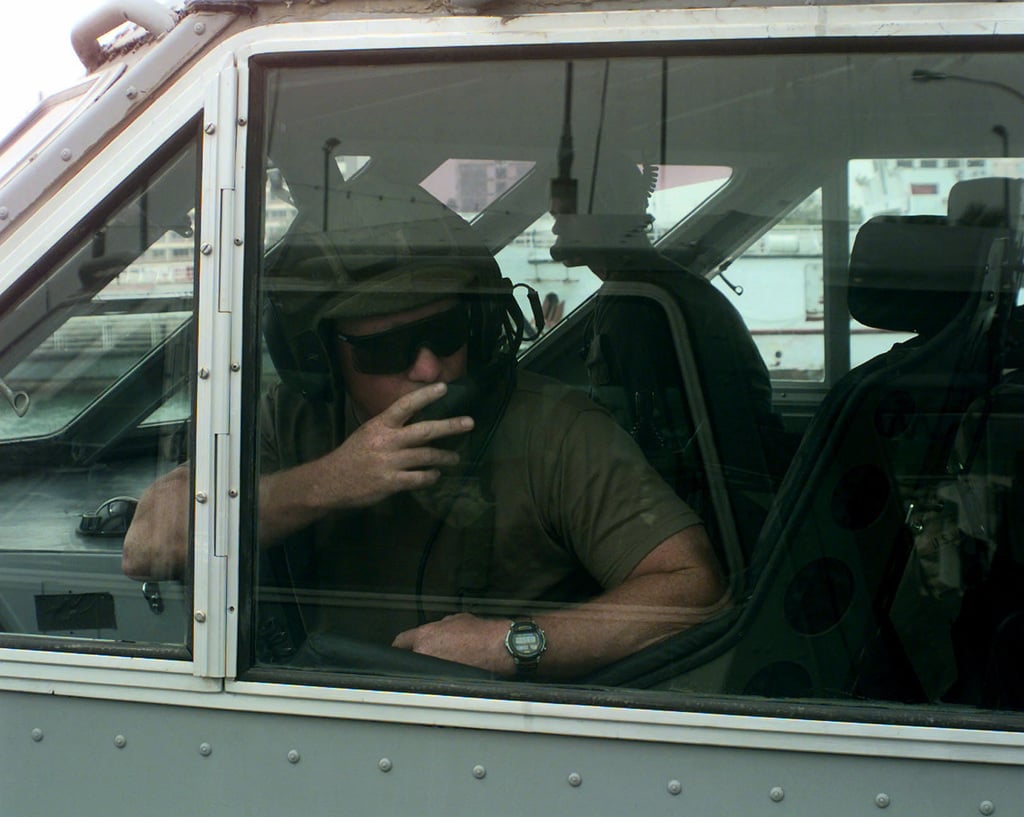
[0,129,198,654]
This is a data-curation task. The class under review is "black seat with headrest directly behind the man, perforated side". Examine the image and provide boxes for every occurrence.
[581,177,1014,701]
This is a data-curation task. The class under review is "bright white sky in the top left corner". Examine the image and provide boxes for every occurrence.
[0,0,132,134]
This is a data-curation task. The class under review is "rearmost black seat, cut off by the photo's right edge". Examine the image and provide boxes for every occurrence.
[946,178,1024,710]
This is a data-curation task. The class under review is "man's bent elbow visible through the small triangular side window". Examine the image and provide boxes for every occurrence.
[121,465,191,581]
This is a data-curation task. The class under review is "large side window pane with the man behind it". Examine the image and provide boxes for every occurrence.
[243,53,1024,717]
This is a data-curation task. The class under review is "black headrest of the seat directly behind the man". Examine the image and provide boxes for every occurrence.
[849,216,1006,336]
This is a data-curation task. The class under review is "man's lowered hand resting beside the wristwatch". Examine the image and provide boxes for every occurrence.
[391,613,515,676]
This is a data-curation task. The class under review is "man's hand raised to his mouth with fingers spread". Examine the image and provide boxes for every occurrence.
[301,383,473,510]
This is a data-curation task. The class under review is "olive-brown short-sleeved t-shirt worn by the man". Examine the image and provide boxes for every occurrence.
[260,372,700,643]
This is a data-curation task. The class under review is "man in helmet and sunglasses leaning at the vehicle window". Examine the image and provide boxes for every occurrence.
[123,185,727,678]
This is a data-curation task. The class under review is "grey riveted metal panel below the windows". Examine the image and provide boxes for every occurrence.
[0,692,1024,817]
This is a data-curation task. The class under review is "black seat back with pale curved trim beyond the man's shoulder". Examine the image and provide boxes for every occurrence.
[588,270,787,575]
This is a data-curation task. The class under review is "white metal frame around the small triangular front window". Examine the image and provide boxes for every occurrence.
[0,44,237,701]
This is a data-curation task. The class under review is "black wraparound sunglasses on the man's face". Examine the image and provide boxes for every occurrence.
[338,304,469,375]
